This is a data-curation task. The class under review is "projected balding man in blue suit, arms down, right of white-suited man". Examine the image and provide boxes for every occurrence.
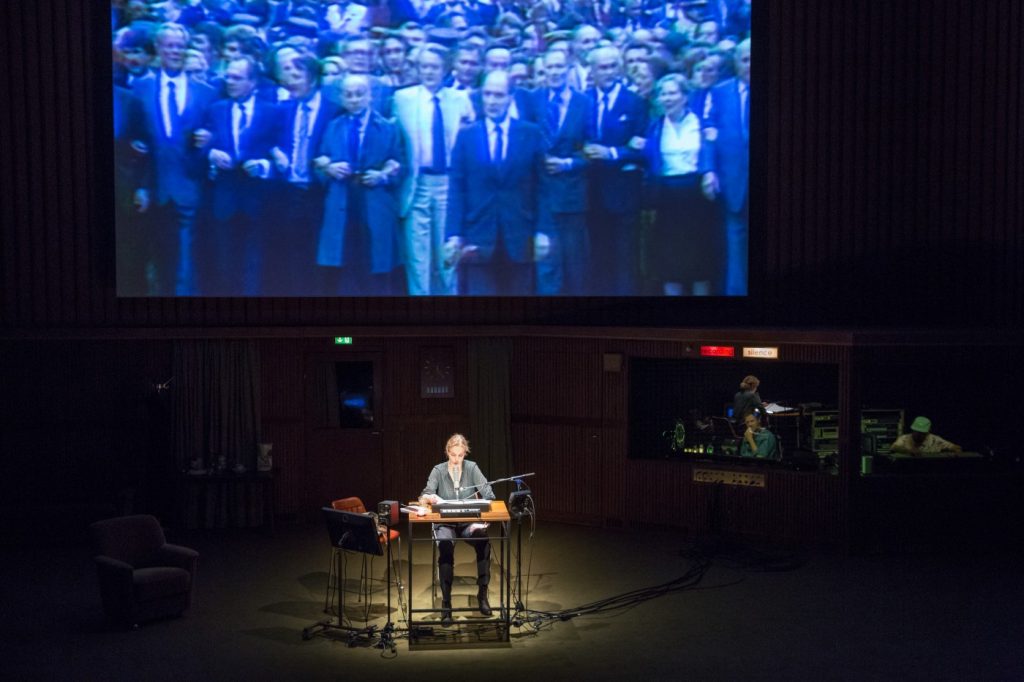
[444,71,544,296]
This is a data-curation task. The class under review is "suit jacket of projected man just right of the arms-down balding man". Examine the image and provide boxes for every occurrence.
[530,88,594,213]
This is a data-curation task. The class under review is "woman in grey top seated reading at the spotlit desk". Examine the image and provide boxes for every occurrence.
[420,433,495,628]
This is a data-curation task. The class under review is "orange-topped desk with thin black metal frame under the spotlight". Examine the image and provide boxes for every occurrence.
[407,500,512,642]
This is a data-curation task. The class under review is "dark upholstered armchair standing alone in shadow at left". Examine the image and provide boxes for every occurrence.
[89,514,199,627]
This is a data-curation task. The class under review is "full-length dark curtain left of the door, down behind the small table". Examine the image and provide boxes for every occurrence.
[171,341,267,527]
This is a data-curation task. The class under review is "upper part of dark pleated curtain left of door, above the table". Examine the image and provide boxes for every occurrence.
[173,341,260,471]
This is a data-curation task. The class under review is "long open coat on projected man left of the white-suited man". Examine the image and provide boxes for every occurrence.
[316,112,404,272]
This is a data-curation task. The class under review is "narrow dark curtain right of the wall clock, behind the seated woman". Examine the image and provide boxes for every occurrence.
[468,338,520,483]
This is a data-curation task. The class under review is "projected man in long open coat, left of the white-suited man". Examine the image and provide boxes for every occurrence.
[313,74,402,296]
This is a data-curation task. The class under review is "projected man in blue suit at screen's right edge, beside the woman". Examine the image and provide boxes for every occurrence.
[702,39,751,296]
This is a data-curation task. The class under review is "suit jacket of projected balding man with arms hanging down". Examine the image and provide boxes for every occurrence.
[445,119,544,263]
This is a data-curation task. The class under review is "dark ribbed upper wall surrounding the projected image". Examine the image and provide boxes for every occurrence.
[0,0,1024,330]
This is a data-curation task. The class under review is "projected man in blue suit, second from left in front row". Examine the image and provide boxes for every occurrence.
[197,56,281,296]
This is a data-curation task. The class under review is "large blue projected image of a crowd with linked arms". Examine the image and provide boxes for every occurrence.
[111,0,751,297]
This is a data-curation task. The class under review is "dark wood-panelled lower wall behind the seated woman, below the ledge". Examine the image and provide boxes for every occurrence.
[0,337,845,545]
